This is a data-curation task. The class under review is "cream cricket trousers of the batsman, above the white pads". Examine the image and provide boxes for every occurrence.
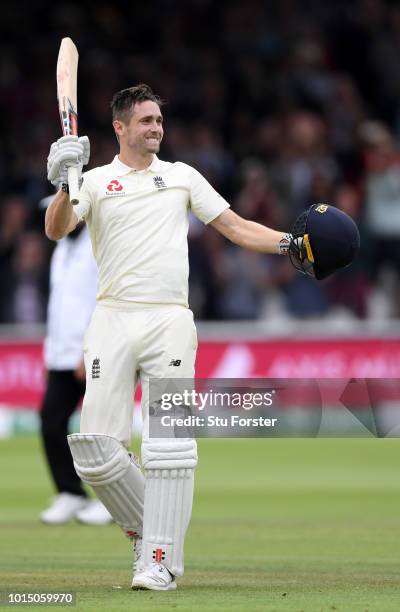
[80,305,197,448]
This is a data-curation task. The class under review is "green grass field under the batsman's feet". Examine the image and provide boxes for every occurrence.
[0,437,400,612]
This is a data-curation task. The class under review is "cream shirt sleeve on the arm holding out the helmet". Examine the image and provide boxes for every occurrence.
[189,167,229,224]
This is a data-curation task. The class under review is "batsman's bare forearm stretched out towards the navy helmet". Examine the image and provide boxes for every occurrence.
[210,209,291,255]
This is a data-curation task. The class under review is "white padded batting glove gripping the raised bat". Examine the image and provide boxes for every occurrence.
[47,136,90,189]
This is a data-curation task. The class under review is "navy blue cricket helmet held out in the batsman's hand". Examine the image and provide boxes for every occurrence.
[289,204,360,280]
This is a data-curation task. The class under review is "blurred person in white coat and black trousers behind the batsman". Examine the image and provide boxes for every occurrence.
[40,198,111,525]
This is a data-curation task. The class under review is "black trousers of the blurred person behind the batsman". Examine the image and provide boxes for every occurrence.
[40,370,86,496]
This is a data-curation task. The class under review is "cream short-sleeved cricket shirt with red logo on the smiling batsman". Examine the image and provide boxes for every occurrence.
[74,156,229,307]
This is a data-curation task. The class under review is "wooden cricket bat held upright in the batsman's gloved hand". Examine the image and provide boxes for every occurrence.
[57,38,79,204]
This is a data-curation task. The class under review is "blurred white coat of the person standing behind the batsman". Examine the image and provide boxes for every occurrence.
[44,227,97,370]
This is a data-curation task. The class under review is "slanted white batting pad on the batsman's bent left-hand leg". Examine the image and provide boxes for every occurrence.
[68,434,144,538]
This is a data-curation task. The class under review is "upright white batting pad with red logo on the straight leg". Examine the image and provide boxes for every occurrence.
[138,440,197,576]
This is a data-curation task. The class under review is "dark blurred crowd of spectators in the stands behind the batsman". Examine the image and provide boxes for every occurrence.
[0,0,400,323]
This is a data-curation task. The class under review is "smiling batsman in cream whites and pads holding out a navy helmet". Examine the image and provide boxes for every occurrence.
[46,84,359,591]
